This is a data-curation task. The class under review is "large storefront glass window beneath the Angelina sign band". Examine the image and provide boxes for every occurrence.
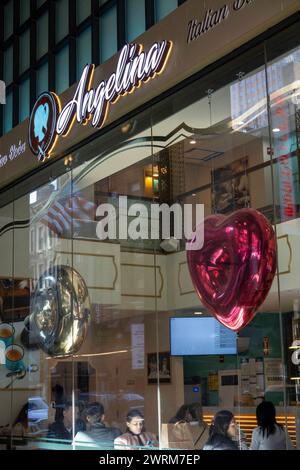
[0,19,300,449]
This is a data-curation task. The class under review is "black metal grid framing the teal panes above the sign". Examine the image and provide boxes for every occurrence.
[0,0,186,136]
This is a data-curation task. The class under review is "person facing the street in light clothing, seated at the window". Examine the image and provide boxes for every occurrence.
[114,410,158,450]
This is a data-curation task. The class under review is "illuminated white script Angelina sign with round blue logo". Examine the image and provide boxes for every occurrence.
[29,41,172,161]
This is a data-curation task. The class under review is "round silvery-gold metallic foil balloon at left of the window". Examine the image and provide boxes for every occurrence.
[30,266,91,356]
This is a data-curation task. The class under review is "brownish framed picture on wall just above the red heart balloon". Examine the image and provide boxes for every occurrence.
[212,157,250,214]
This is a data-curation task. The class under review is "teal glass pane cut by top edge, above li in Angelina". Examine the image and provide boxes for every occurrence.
[125,0,146,42]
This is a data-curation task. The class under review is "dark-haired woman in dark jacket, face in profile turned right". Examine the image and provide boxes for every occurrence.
[203,410,239,450]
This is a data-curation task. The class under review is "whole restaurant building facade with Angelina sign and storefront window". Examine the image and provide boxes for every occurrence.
[0,0,300,449]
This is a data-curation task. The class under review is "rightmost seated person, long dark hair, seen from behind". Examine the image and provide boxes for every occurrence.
[250,401,293,450]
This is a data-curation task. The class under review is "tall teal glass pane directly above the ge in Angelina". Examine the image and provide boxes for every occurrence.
[99,6,118,62]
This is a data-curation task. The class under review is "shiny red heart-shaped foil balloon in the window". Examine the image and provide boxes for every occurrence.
[187,209,276,331]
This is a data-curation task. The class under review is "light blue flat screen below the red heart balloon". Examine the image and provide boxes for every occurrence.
[170,317,237,356]
